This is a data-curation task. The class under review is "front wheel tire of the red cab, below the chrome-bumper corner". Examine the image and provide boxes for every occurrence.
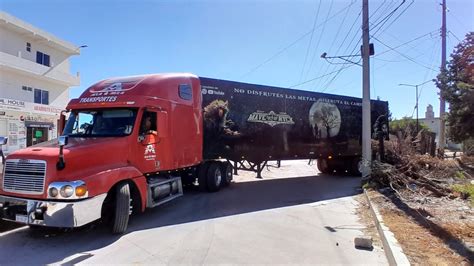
[112,183,130,234]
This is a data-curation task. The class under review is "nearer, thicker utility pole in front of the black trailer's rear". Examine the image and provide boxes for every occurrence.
[362,0,372,177]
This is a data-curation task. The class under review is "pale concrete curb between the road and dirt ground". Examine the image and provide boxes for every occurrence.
[364,189,410,266]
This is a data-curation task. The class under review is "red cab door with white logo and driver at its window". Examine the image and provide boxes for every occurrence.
[137,110,160,173]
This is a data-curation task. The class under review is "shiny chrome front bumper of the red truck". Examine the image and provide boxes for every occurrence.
[0,193,107,227]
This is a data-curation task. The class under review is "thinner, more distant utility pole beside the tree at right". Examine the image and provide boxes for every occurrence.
[438,0,446,155]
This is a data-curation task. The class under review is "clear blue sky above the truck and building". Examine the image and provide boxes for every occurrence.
[0,0,474,118]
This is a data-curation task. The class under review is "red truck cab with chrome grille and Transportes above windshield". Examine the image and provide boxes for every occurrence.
[0,74,231,233]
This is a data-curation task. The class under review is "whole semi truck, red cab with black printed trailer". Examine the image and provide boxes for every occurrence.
[0,74,388,233]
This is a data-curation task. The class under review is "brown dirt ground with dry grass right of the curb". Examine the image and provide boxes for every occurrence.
[369,190,474,265]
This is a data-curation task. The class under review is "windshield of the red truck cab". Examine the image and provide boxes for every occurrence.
[63,109,137,137]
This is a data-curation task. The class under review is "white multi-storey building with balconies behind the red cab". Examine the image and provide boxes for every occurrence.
[0,11,80,154]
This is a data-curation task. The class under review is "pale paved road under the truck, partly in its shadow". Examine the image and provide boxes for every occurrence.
[0,161,387,265]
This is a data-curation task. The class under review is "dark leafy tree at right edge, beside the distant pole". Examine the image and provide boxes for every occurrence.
[437,32,474,142]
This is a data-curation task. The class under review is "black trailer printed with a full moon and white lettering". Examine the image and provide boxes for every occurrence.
[200,78,388,177]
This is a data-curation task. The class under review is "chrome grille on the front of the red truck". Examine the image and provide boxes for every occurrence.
[3,159,46,194]
